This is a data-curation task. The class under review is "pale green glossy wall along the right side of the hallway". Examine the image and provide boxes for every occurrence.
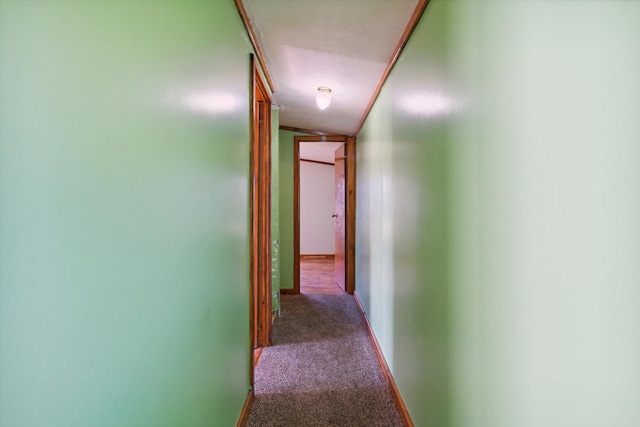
[356,0,640,427]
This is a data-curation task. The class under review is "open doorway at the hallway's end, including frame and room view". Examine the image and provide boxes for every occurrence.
[293,135,355,294]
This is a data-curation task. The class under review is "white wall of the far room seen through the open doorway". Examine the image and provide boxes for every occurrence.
[300,161,335,255]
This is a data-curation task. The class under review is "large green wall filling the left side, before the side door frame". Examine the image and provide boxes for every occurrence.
[0,0,258,427]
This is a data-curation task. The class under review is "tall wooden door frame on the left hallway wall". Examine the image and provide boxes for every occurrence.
[249,55,272,386]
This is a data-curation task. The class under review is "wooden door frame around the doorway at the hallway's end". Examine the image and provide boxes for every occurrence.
[294,135,356,295]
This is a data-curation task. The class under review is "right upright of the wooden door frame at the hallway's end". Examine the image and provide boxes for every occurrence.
[345,137,356,295]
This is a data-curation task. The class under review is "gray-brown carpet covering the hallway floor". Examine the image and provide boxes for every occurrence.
[246,294,402,427]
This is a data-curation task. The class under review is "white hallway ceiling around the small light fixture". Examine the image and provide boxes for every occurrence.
[242,0,418,135]
